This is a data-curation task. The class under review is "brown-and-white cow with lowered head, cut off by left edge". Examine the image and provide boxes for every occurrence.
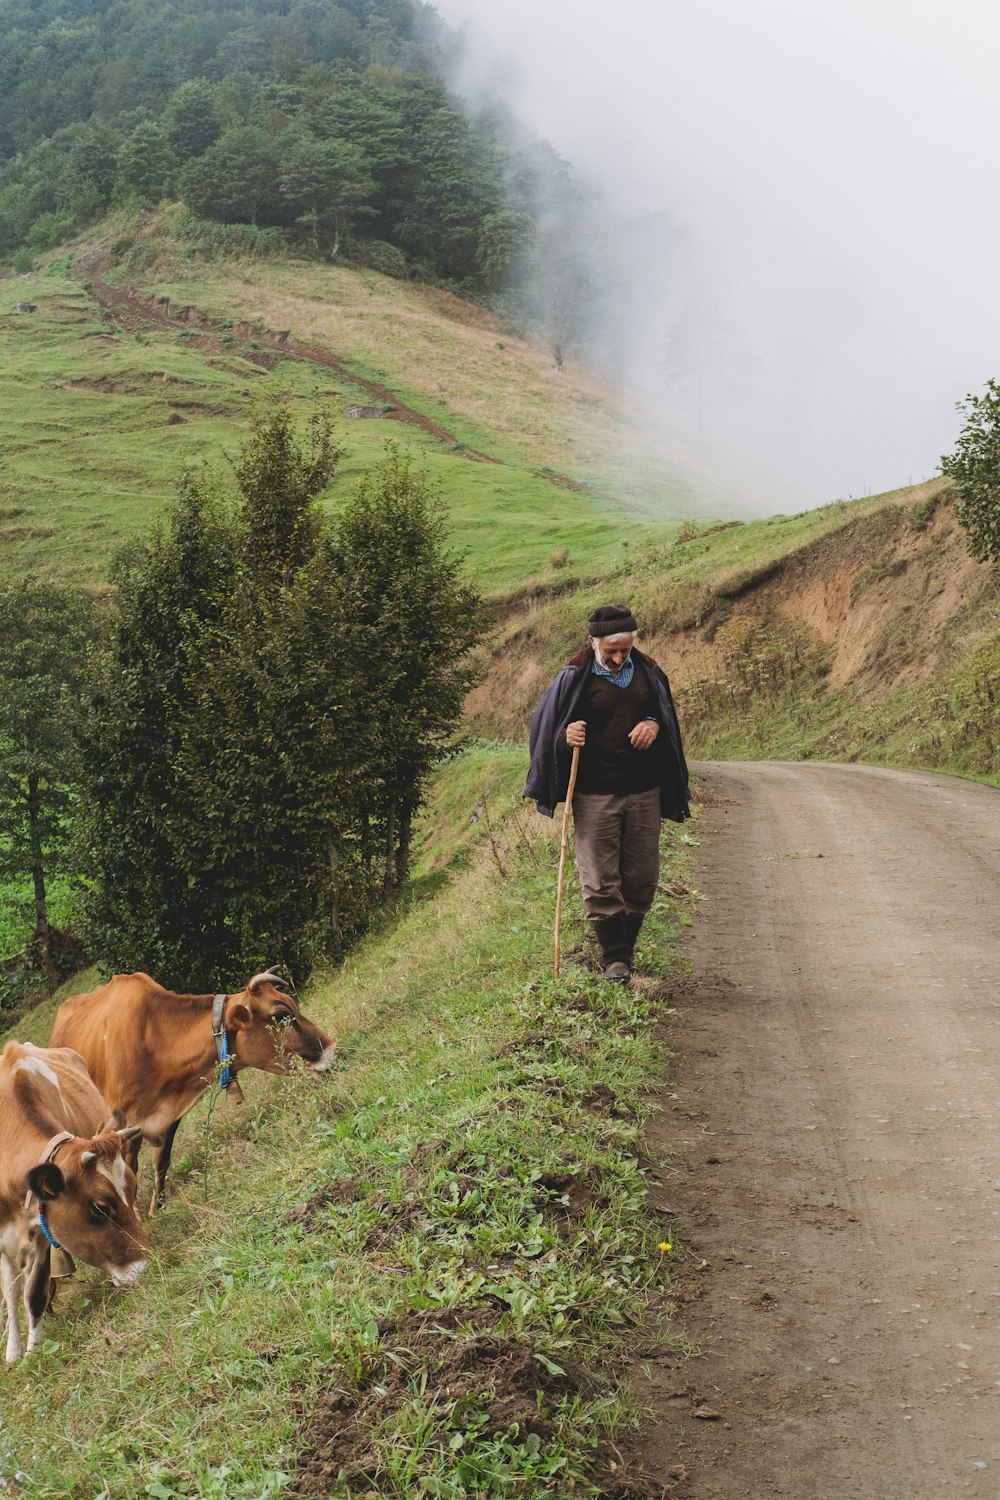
[0,1041,148,1361]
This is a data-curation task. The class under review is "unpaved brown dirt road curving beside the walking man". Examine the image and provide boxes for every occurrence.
[637,764,1000,1500]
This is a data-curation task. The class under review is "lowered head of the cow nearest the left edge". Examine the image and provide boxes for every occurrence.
[27,1116,148,1287]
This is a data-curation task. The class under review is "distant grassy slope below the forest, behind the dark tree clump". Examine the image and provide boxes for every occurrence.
[0,222,761,596]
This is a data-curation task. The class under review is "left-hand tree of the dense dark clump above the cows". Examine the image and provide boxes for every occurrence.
[78,479,234,989]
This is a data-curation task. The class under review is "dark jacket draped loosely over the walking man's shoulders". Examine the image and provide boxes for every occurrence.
[523,647,691,824]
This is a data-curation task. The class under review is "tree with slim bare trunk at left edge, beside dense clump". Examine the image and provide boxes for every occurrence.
[0,582,96,972]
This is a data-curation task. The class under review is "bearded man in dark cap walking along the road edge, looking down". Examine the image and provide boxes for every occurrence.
[525,605,690,984]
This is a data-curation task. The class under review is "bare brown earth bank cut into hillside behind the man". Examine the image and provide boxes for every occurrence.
[466,480,997,738]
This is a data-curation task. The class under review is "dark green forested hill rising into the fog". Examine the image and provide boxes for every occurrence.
[0,0,571,307]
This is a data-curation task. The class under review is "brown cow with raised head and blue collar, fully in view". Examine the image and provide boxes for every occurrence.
[49,971,334,1214]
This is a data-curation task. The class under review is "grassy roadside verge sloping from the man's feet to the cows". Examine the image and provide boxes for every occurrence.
[0,747,701,1500]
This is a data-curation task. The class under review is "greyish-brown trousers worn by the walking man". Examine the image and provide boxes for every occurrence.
[573,786,660,921]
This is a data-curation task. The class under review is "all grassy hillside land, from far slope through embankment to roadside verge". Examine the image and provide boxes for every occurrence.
[0,205,1000,1500]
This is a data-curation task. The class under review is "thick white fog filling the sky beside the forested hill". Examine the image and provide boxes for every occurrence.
[435,0,1000,510]
